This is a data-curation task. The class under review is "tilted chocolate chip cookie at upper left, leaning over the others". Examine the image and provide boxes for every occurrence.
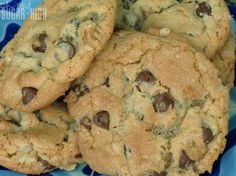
[0,0,117,112]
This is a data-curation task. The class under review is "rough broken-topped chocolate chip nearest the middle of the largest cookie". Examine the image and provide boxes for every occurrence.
[153,92,175,112]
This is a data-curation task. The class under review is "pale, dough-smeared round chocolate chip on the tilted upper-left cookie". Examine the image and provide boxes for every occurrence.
[55,41,75,62]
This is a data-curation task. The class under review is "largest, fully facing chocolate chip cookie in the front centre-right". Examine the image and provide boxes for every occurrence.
[65,32,229,176]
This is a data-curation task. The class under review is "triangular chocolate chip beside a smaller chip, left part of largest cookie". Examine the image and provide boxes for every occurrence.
[93,111,110,130]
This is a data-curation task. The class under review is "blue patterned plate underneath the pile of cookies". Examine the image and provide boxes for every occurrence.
[0,0,236,176]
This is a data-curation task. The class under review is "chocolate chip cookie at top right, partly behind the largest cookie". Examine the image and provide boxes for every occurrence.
[116,0,231,58]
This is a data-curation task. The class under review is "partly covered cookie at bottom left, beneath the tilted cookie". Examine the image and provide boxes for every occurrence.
[0,105,82,174]
